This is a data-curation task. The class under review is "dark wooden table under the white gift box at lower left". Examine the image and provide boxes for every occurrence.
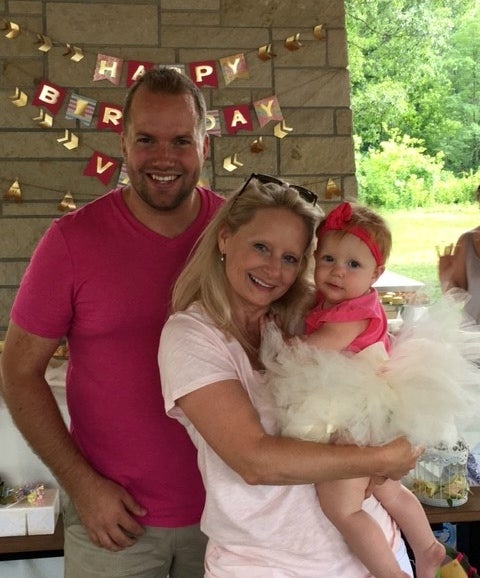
[0,516,63,561]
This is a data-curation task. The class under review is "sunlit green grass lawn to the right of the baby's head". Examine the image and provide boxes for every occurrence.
[379,204,480,301]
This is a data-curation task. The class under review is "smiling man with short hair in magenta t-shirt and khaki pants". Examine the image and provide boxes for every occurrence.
[2,68,222,578]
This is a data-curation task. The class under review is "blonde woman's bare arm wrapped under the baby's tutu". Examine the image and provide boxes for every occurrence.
[177,380,420,485]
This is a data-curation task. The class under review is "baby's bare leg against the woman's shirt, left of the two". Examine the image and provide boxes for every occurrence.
[316,478,408,578]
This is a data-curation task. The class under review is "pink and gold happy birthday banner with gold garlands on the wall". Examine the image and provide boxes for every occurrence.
[0,20,326,210]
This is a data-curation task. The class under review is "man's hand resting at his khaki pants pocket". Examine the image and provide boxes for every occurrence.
[72,475,147,552]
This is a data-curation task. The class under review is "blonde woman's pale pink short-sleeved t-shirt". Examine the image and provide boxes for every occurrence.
[159,305,403,578]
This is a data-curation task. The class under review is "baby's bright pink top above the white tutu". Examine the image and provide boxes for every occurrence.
[305,288,390,353]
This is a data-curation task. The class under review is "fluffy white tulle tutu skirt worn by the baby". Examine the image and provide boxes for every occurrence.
[262,298,480,446]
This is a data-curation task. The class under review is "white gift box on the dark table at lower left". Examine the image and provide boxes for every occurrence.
[0,489,60,537]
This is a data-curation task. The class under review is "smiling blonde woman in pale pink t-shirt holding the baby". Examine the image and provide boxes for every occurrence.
[159,175,418,578]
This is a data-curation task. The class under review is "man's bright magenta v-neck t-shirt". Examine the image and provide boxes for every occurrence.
[12,188,222,527]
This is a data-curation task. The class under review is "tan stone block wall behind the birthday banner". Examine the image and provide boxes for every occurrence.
[0,0,356,332]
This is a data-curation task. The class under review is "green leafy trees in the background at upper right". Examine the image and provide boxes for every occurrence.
[345,0,480,176]
